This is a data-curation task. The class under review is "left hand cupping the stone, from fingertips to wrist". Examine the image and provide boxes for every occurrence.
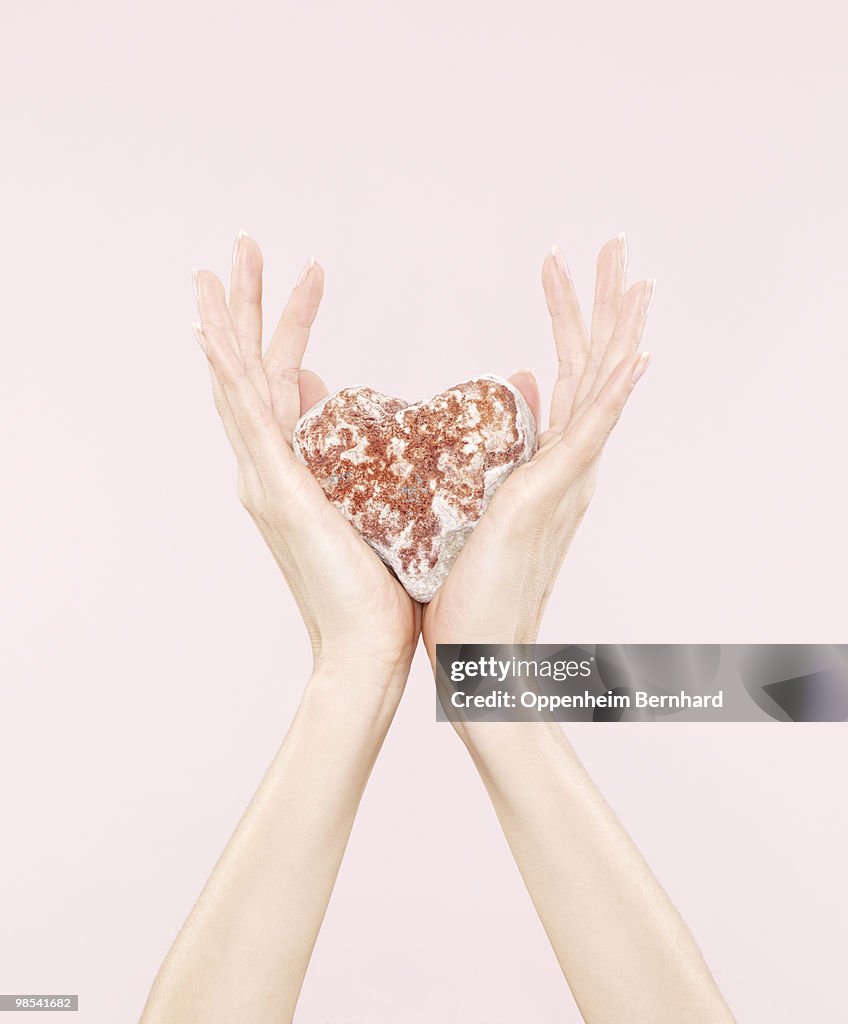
[194,234,421,695]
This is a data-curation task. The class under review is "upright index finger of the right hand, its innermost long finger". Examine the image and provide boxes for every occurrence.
[542,246,589,430]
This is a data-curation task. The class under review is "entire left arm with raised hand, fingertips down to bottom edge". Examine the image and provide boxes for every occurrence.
[142,236,420,1024]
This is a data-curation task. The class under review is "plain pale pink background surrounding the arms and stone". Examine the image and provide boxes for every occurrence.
[0,0,848,1024]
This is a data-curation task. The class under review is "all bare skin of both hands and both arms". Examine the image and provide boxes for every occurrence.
[141,234,733,1024]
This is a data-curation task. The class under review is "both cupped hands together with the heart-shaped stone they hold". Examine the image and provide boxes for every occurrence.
[195,233,653,685]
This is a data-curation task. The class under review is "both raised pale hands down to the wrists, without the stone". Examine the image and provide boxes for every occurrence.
[194,233,653,696]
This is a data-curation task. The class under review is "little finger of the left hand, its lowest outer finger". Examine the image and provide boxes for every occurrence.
[195,323,292,481]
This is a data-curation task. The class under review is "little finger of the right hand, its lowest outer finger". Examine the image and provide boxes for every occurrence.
[542,352,650,483]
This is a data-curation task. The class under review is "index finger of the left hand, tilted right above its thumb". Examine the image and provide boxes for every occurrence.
[264,258,324,437]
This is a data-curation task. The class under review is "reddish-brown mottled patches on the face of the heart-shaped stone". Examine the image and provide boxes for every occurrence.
[298,380,523,570]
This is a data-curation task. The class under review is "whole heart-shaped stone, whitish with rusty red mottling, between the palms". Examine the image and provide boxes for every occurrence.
[294,375,537,602]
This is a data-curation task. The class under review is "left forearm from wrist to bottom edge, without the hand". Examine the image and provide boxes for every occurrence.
[142,667,402,1024]
